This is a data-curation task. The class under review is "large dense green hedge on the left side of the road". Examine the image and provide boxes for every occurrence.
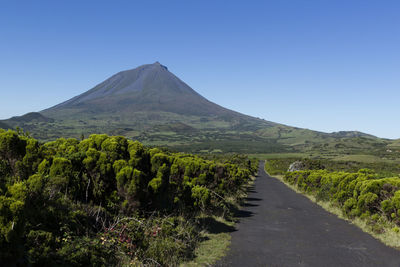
[0,130,256,266]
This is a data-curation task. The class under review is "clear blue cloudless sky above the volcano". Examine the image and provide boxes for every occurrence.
[0,0,400,138]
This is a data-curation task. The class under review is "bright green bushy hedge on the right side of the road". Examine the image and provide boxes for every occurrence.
[284,169,400,229]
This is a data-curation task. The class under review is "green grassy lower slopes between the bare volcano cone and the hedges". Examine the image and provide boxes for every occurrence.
[0,104,400,156]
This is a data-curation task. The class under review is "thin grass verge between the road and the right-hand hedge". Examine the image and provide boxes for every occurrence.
[265,166,400,249]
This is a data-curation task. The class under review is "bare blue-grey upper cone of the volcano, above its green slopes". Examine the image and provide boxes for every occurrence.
[42,61,237,117]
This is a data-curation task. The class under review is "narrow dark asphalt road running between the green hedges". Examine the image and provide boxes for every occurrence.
[216,163,400,267]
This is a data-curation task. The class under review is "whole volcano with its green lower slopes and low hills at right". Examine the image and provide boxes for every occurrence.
[3,62,387,154]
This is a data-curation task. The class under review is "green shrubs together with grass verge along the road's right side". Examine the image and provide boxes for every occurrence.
[265,159,400,247]
